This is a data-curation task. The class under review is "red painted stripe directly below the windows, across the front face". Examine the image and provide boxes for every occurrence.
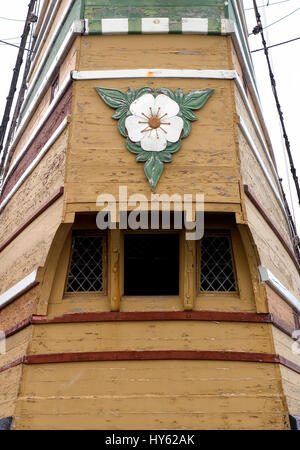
[32,311,271,324]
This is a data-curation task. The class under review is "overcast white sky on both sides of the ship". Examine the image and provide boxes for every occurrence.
[0,0,300,230]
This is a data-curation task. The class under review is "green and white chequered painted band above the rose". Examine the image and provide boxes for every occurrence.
[85,17,235,35]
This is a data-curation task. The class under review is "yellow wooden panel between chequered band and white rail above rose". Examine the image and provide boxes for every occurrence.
[77,34,231,70]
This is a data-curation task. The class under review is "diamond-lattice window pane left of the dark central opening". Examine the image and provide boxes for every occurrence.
[66,236,103,292]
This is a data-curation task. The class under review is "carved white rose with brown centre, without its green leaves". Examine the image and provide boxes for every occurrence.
[125,94,183,152]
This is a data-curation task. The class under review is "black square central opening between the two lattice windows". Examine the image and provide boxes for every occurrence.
[124,234,179,295]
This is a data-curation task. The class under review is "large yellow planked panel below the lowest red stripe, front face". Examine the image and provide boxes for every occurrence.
[14,361,289,429]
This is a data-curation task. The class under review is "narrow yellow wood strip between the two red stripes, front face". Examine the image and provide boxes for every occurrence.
[29,321,273,354]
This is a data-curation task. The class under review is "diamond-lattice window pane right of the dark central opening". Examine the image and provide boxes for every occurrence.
[200,236,236,292]
